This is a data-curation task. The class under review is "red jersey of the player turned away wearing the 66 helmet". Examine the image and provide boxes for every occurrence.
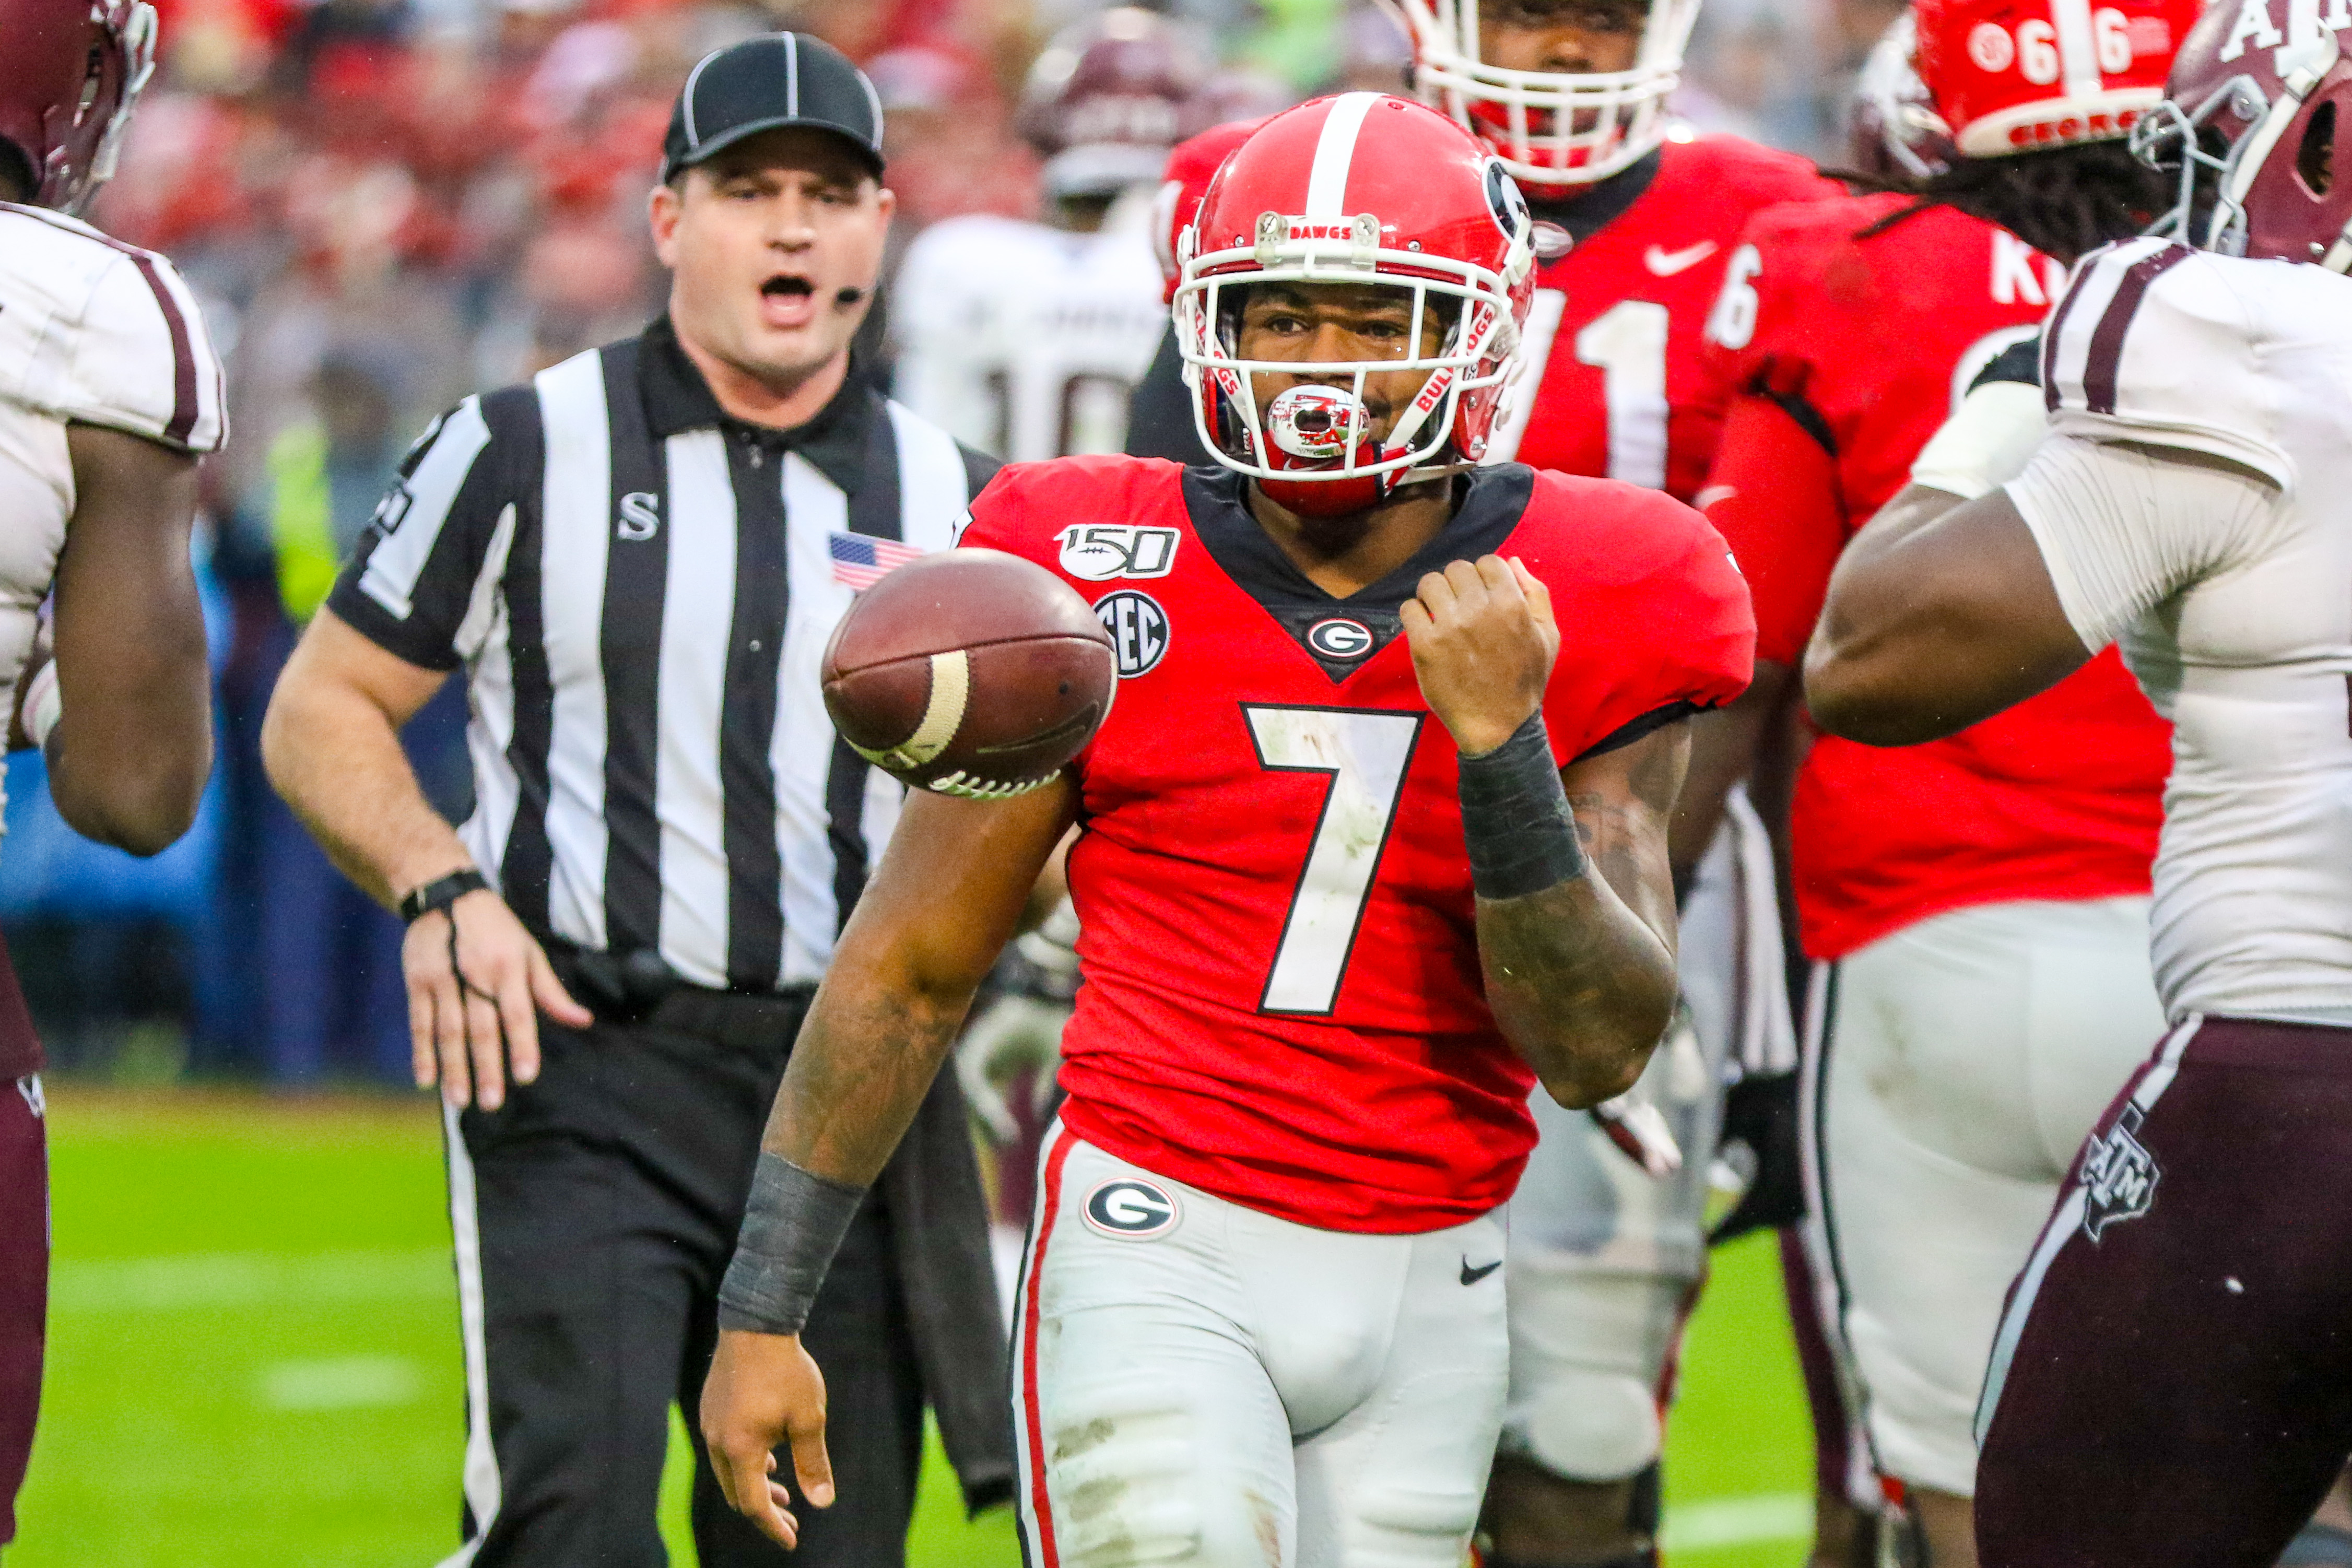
[1708,195,2171,959]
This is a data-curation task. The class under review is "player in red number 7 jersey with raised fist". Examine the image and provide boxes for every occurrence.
[703,94,1750,1568]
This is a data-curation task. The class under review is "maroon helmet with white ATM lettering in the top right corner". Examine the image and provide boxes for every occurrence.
[2131,0,2352,273]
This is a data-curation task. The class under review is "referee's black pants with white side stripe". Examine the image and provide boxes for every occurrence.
[449,992,924,1568]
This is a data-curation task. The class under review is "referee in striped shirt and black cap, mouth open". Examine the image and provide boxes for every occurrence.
[263,33,1012,1568]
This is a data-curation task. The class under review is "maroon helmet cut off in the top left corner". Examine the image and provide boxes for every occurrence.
[0,0,155,211]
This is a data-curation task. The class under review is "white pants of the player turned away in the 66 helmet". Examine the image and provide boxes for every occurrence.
[1804,898,2164,1498]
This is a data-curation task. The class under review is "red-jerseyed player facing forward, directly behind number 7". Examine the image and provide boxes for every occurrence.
[1129,12,1839,1563]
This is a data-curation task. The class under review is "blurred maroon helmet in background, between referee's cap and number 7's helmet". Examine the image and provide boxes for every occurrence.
[1021,5,1207,200]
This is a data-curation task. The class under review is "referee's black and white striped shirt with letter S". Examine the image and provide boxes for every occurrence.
[330,320,995,989]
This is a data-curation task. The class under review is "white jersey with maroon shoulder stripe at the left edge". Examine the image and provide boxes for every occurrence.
[0,202,228,693]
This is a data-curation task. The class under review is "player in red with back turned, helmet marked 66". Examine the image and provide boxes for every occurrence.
[1691,0,2199,1568]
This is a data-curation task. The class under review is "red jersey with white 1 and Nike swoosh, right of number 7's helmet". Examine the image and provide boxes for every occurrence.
[1489,136,1837,501]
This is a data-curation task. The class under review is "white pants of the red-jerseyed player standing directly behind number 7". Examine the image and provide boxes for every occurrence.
[1503,792,1797,1481]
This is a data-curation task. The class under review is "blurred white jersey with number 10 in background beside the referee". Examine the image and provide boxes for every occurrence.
[891,200,1169,463]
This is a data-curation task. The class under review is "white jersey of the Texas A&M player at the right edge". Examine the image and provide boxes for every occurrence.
[2008,240,2352,1025]
